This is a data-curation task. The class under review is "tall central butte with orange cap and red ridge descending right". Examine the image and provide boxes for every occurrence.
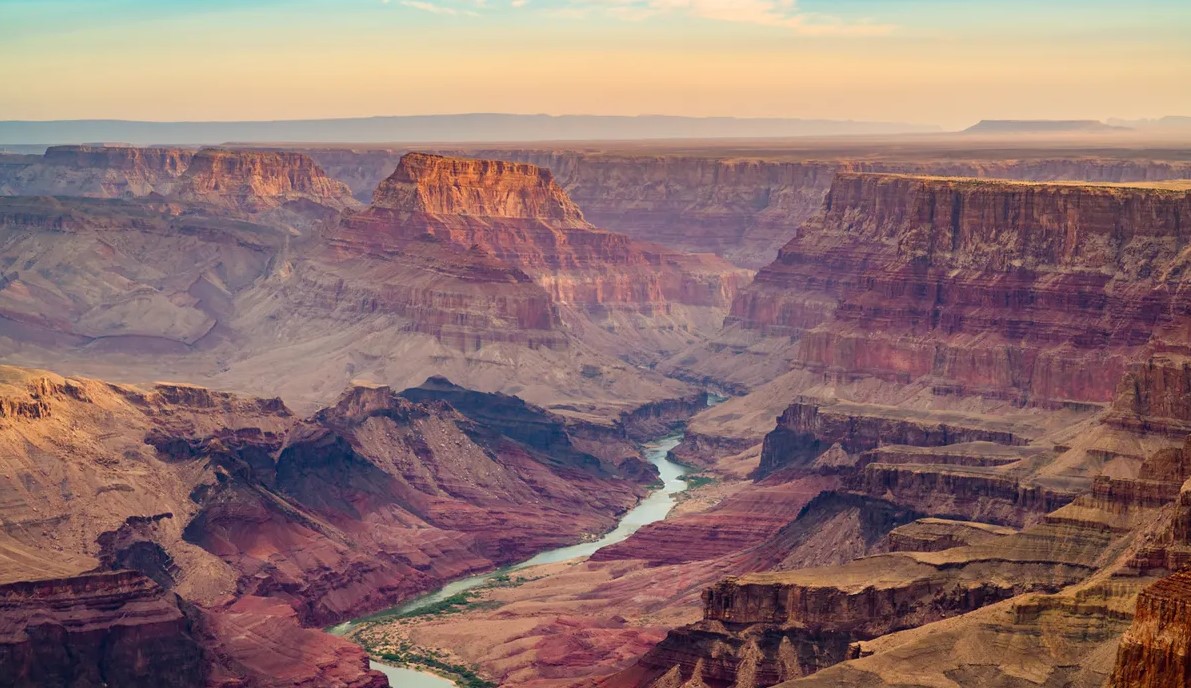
[331,154,748,308]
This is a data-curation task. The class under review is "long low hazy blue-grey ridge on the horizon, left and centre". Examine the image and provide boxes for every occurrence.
[0,114,941,145]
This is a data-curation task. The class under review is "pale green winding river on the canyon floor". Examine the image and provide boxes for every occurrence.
[331,433,686,688]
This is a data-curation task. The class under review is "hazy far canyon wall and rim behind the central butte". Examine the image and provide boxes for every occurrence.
[308,149,1191,268]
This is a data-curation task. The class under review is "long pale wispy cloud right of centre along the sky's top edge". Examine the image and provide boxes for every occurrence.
[547,0,893,36]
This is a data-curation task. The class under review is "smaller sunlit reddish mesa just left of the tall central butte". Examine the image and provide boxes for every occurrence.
[169,149,351,211]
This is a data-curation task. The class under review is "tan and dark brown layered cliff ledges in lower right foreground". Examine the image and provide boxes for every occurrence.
[601,452,1185,688]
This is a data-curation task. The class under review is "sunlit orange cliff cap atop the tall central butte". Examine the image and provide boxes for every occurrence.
[373,152,591,223]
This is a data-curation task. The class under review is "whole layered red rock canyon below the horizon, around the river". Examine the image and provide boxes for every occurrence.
[0,139,1191,688]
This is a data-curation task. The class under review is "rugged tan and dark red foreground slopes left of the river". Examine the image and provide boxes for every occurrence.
[0,367,654,688]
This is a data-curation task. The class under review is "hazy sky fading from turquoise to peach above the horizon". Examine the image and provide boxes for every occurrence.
[0,0,1191,126]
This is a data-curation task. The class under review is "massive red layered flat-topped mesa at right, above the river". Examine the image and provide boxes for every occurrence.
[729,174,1191,404]
